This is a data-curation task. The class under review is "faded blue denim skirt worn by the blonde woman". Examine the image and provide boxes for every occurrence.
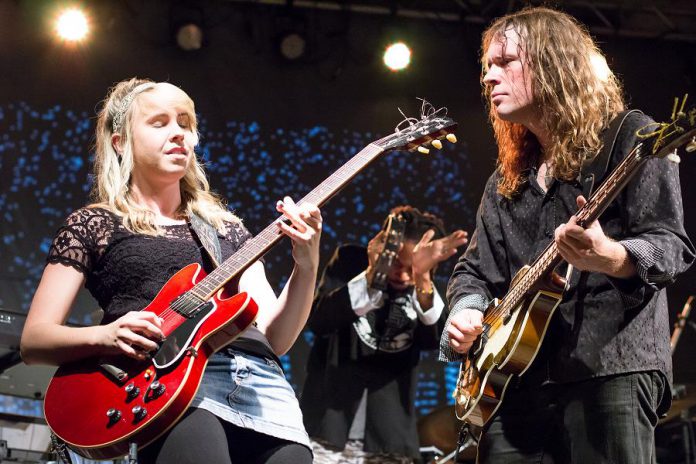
[191,348,311,449]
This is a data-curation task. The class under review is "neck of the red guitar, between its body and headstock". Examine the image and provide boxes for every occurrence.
[190,143,384,300]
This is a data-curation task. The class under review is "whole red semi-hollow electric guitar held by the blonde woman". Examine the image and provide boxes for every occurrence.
[44,106,456,459]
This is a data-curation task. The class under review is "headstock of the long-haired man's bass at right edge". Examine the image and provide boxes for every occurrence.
[638,95,696,163]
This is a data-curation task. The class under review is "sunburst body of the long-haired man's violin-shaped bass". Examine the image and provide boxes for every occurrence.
[454,267,563,427]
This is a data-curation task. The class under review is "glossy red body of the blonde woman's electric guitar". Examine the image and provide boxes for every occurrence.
[44,264,258,459]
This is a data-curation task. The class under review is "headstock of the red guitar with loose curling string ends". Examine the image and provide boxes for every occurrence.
[374,100,457,153]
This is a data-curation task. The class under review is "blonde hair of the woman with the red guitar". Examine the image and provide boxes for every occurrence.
[91,78,239,235]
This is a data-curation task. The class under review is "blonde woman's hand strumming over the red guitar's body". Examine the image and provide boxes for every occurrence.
[100,311,164,360]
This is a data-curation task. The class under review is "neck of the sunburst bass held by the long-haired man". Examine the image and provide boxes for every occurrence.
[496,142,648,315]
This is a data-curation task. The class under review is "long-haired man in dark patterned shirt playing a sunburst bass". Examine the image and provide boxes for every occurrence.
[440,8,694,464]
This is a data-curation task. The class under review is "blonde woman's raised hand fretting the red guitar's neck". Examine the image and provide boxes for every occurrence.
[276,197,322,270]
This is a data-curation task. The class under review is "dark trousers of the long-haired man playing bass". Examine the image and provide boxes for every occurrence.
[477,371,669,464]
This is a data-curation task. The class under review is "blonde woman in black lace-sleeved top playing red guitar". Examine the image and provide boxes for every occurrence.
[21,79,322,463]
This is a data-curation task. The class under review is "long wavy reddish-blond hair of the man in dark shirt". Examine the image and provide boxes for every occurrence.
[481,7,625,198]
